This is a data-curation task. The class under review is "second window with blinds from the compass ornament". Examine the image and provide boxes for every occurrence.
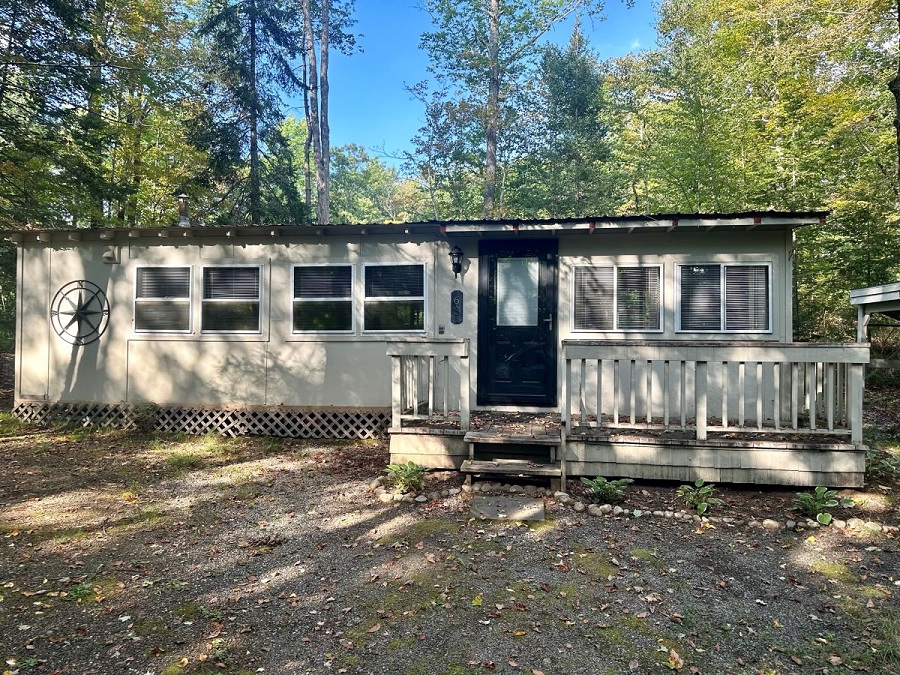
[200,266,260,333]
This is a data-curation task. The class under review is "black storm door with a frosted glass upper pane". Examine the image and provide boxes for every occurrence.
[477,240,557,406]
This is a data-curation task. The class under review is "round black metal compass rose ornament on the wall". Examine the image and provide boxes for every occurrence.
[50,280,109,345]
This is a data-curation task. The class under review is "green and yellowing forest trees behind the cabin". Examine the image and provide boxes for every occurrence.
[0,0,900,348]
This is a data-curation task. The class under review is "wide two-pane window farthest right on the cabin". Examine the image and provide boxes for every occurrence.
[677,265,772,333]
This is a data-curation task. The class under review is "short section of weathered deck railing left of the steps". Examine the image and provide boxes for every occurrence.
[387,338,469,431]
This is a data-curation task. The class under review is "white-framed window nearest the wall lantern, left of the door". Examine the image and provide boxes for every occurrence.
[363,265,425,332]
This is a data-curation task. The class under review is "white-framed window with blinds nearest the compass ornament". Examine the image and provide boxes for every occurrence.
[134,267,191,333]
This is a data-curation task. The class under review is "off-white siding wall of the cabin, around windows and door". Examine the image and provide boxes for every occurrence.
[16,227,791,407]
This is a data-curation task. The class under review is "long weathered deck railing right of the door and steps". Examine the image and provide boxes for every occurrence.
[562,340,869,443]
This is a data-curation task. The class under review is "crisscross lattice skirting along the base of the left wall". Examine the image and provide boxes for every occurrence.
[13,402,391,439]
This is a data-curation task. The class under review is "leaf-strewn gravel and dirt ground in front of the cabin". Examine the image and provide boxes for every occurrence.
[0,378,900,675]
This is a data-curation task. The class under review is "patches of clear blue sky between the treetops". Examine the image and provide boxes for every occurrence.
[314,0,655,164]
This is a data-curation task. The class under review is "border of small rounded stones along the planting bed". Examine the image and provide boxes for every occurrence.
[369,476,900,536]
